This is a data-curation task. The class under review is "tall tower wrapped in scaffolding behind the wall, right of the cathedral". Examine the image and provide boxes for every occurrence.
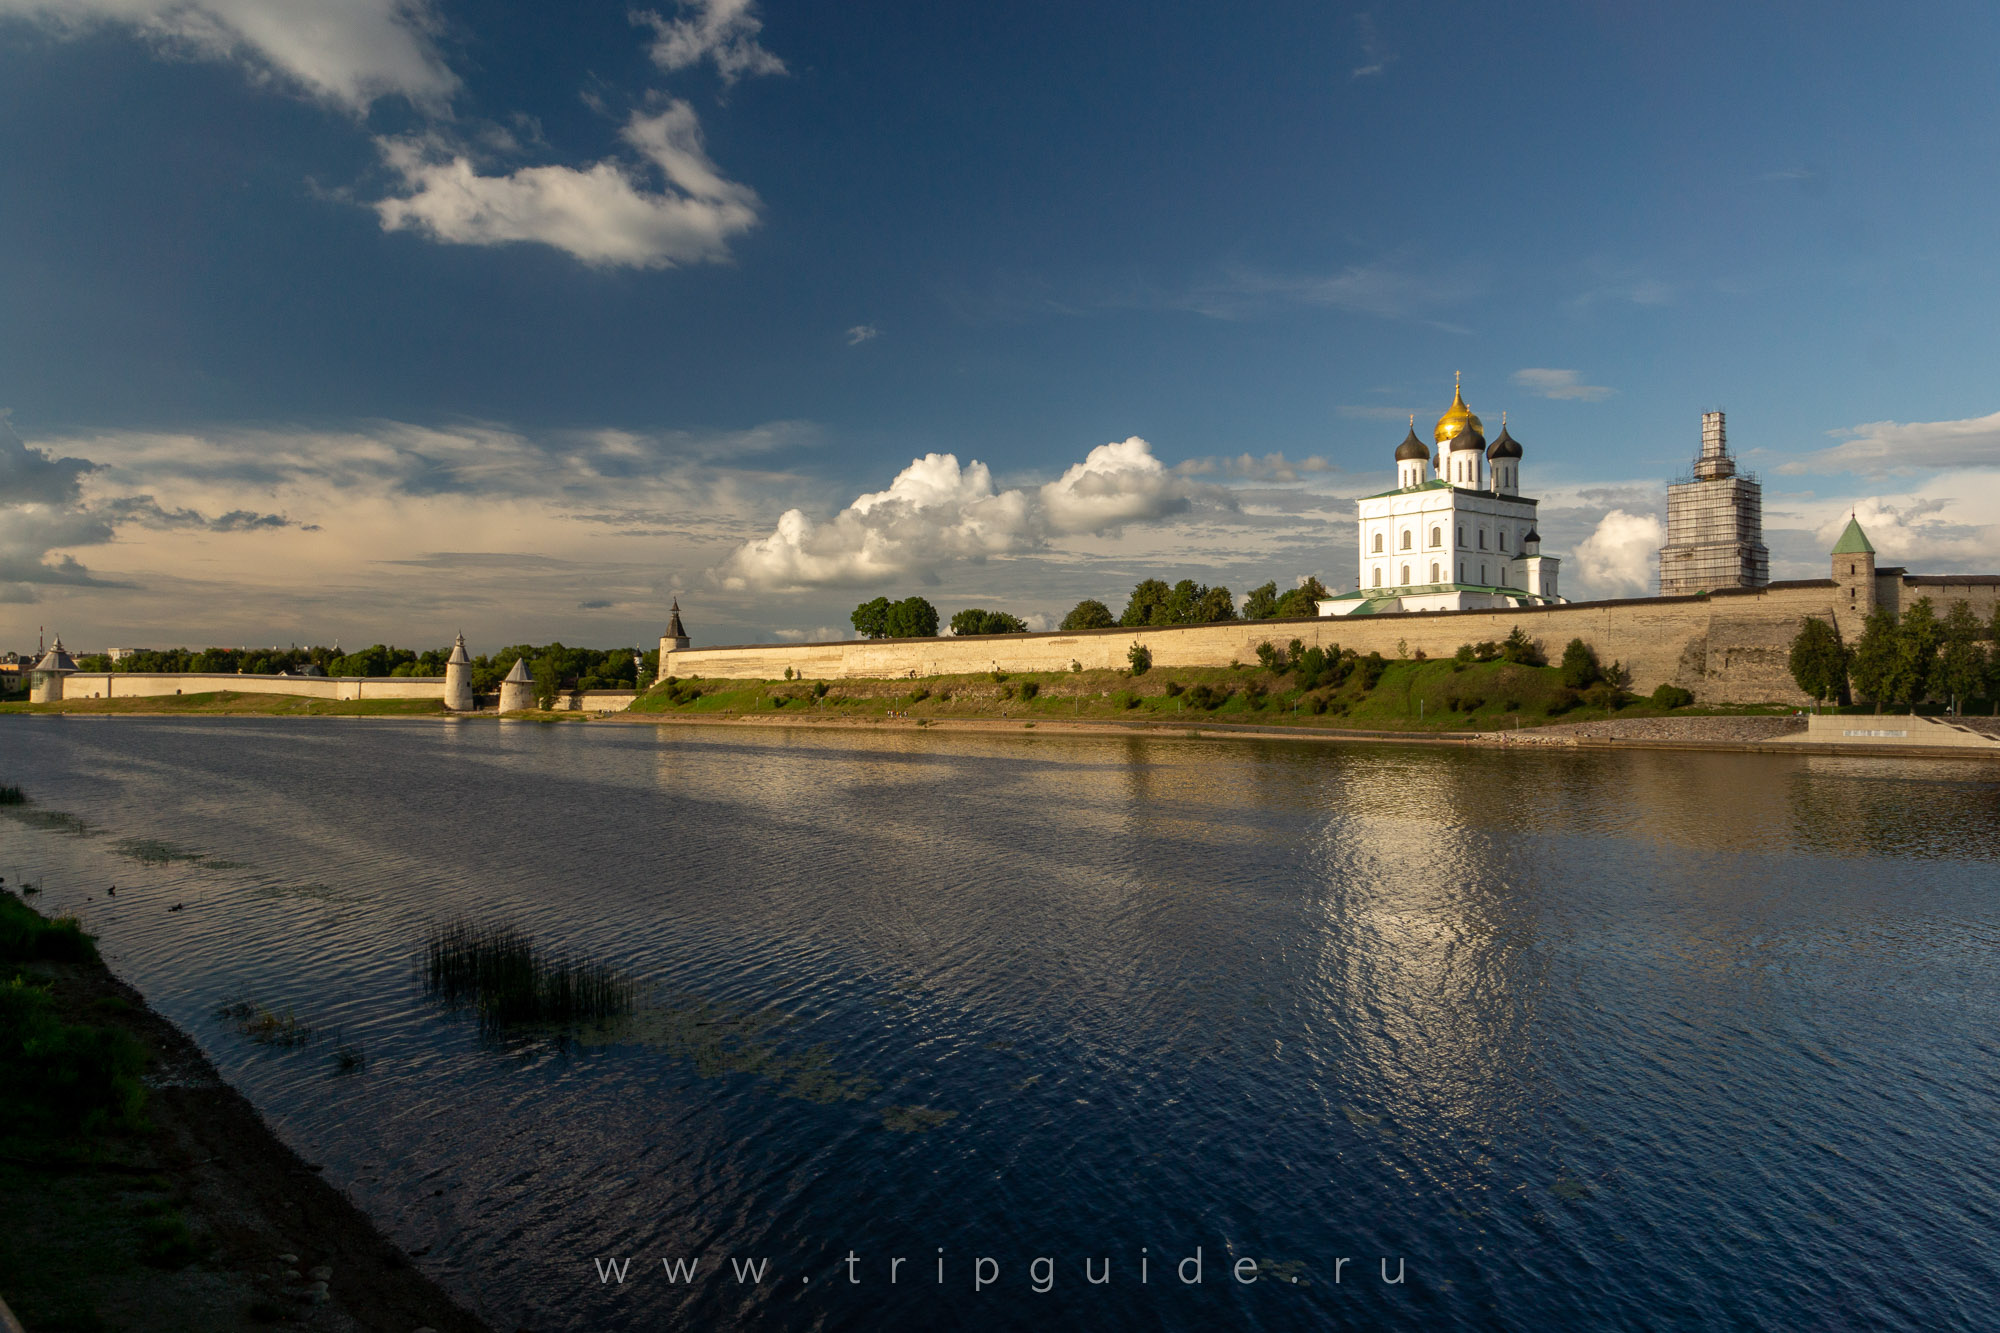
[1660,412,1770,596]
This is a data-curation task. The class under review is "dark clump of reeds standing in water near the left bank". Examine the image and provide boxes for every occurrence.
[424,923,638,1027]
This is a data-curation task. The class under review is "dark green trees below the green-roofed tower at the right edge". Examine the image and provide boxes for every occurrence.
[1790,596,2000,713]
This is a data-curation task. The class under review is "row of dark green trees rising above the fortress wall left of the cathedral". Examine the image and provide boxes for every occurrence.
[852,576,1332,638]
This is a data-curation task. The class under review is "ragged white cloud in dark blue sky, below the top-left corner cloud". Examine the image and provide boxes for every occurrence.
[374,102,758,268]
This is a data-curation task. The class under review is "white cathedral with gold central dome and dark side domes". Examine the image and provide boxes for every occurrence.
[1318,376,1564,616]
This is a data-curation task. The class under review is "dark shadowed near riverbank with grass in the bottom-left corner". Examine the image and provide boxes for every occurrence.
[0,891,486,1333]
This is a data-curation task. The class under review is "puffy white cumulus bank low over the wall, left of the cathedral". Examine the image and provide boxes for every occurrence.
[714,436,1194,590]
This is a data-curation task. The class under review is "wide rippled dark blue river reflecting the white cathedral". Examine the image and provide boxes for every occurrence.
[0,717,2000,1333]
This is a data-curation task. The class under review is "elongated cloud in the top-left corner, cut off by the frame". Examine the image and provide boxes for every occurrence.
[0,0,458,112]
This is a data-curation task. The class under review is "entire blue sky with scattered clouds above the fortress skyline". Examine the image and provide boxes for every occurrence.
[0,0,2000,644]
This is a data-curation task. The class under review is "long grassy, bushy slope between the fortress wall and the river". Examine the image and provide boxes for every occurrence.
[616,656,1790,733]
